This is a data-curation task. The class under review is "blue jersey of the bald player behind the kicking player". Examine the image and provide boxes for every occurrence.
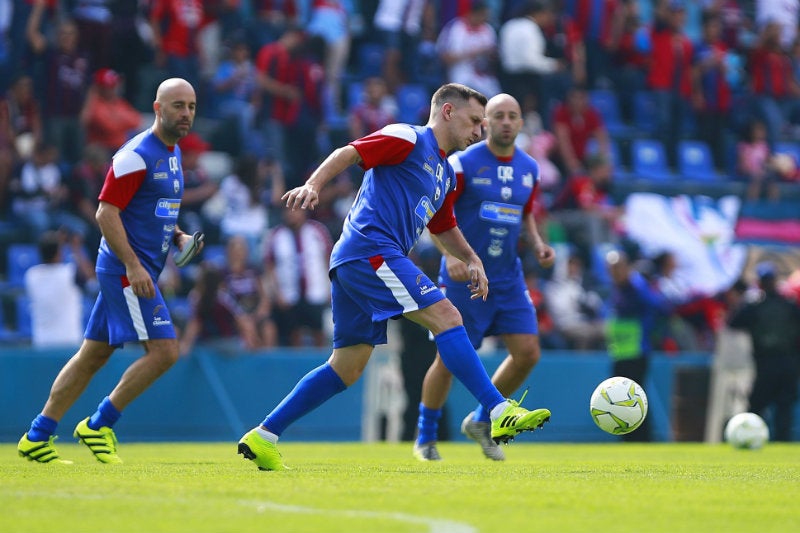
[439,141,539,286]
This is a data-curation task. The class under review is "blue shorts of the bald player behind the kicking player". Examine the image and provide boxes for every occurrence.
[442,275,539,349]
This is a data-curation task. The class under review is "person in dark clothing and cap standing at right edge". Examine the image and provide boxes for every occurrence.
[728,262,800,441]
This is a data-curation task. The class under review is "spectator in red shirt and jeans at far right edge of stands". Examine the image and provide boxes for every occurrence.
[748,22,800,147]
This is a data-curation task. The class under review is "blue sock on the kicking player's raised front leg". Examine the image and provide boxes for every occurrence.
[433,326,505,411]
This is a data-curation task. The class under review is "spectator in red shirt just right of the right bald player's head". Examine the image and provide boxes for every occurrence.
[553,85,610,175]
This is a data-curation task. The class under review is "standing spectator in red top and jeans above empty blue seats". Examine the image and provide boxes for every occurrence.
[647,0,693,166]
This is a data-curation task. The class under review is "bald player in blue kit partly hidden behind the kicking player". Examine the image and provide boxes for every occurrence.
[414,94,555,461]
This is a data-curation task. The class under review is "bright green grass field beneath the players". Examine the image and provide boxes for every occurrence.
[0,439,800,533]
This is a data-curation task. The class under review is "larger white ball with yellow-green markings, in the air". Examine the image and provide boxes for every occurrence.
[589,376,647,435]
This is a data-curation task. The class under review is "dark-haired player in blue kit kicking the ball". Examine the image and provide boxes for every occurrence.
[238,84,550,470]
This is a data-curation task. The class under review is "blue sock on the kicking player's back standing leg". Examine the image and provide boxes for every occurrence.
[262,363,347,436]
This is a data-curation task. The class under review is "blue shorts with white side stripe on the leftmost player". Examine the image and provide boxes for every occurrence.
[84,273,175,346]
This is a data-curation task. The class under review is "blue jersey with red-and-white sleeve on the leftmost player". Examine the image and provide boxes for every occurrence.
[97,129,183,279]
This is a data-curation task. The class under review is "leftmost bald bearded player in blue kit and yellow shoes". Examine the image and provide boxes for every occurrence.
[17,78,202,463]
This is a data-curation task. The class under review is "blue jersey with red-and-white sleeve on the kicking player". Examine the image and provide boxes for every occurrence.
[330,124,455,269]
